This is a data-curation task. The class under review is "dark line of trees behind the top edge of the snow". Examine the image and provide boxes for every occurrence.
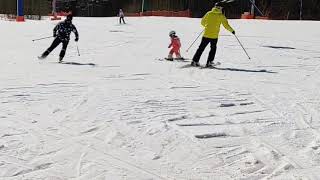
[0,0,320,20]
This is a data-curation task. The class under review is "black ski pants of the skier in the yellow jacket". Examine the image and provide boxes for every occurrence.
[192,37,218,64]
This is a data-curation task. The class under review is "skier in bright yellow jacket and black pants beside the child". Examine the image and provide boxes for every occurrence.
[191,2,235,67]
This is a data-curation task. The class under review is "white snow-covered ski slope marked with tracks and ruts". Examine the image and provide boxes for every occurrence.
[0,17,320,180]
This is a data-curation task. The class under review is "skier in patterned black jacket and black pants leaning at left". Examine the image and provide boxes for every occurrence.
[39,14,79,62]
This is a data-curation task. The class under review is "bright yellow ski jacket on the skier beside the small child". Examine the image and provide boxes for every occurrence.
[201,7,234,39]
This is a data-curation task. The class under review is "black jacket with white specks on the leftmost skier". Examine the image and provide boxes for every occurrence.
[53,21,79,41]
